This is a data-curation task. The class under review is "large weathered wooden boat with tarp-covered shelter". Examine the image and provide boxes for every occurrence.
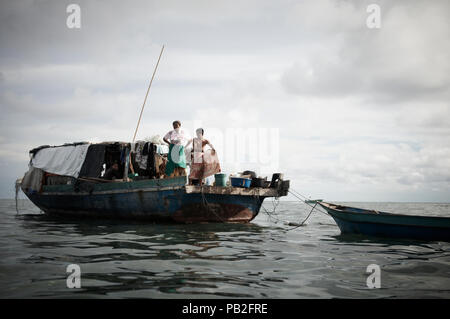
[16,142,289,223]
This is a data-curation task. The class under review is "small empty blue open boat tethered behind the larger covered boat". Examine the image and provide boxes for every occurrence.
[319,202,450,241]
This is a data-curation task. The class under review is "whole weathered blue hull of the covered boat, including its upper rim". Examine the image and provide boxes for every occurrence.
[26,178,284,223]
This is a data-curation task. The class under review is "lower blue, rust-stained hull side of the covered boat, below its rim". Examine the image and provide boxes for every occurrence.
[28,188,264,222]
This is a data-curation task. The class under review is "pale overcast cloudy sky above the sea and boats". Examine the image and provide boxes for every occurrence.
[0,0,450,202]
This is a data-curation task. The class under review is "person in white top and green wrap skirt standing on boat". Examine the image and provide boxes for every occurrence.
[163,121,188,177]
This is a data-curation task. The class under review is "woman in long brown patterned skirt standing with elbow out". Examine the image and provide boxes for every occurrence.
[186,128,220,184]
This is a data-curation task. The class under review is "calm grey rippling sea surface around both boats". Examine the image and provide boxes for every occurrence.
[0,199,450,298]
